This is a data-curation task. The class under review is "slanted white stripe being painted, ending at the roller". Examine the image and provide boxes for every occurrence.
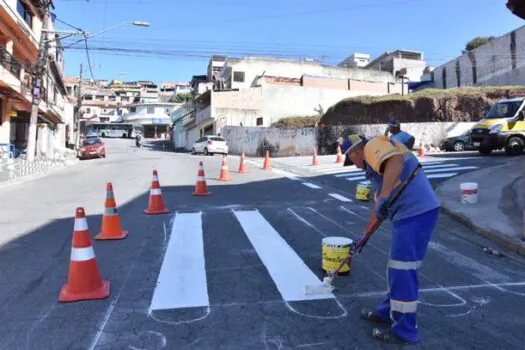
[234,210,335,301]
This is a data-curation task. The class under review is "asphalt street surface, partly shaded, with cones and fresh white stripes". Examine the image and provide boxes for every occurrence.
[0,140,525,350]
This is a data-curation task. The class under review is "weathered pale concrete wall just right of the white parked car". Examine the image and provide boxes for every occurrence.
[222,126,317,157]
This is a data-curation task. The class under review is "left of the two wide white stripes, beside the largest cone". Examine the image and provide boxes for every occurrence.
[150,213,210,310]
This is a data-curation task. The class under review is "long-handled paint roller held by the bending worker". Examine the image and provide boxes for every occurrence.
[304,163,421,295]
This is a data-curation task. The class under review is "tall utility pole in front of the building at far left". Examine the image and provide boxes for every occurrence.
[27,0,52,162]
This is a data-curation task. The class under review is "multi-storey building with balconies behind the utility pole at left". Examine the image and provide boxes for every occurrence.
[0,0,73,157]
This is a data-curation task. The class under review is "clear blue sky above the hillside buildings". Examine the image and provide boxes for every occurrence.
[54,0,524,83]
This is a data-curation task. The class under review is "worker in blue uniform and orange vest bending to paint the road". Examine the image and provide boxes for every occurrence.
[348,135,440,344]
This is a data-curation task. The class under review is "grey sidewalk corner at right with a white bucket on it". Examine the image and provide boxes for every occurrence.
[436,157,525,256]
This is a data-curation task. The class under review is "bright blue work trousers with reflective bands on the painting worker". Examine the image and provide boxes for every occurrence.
[377,208,439,341]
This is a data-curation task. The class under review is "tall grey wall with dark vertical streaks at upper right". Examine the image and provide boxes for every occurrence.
[434,26,525,88]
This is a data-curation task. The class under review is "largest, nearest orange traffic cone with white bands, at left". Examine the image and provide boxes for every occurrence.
[58,208,110,302]
